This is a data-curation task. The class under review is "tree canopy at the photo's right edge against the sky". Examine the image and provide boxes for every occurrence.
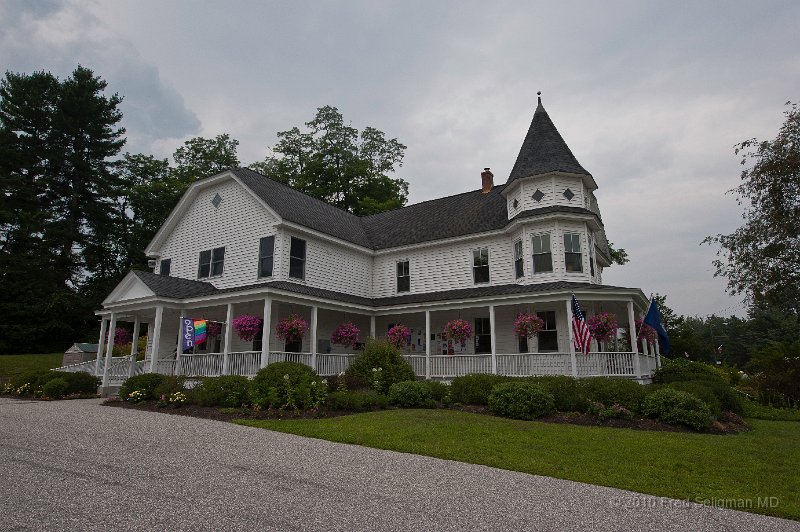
[703,102,800,316]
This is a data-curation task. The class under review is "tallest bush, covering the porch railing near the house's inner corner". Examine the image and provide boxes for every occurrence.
[345,339,416,393]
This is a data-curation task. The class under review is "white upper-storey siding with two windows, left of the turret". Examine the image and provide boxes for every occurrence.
[373,236,514,297]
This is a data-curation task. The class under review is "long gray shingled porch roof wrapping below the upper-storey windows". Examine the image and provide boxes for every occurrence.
[133,270,629,308]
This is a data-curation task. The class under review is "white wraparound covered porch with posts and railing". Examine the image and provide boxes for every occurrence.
[54,278,659,386]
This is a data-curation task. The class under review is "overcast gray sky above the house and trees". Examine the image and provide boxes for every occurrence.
[0,0,800,316]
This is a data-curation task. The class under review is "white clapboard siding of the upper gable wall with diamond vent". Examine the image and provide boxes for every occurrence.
[159,180,277,288]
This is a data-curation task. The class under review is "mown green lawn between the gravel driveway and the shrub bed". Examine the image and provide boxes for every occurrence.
[237,410,800,520]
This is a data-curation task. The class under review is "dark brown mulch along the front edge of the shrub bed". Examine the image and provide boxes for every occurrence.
[103,400,750,434]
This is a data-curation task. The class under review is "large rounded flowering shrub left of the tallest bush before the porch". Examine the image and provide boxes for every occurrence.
[249,362,327,409]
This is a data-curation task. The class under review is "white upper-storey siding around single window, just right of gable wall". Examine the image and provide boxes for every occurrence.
[281,231,372,297]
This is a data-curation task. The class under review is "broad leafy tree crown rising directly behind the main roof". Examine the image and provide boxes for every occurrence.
[250,106,408,215]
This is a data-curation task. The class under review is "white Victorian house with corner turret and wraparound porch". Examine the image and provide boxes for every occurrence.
[59,99,658,385]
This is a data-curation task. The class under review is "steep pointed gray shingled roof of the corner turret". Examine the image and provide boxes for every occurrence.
[506,98,591,184]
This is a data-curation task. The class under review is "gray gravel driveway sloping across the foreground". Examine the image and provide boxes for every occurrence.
[0,398,800,531]
